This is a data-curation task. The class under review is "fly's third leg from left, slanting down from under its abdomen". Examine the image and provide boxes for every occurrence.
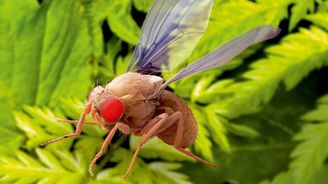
[123,113,168,178]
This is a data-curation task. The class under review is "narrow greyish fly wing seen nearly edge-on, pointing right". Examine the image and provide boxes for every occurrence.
[163,26,280,87]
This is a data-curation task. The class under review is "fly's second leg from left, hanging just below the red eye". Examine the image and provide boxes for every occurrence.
[89,122,130,176]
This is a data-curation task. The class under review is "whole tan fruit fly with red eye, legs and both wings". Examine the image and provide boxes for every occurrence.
[42,0,280,177]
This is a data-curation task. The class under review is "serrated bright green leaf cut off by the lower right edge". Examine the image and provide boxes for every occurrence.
[289,95,328,183]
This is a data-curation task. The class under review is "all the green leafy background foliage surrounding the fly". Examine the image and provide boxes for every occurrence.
[0,0,328,184]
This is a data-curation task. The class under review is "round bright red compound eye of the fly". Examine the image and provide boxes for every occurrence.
[101,96,125,123]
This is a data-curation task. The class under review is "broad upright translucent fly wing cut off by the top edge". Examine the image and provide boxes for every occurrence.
[127,0,213,73]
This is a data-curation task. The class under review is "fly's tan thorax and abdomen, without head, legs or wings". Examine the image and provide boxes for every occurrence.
[104,72,197,148]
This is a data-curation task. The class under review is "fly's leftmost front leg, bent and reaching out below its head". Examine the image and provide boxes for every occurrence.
[41,104,91,147]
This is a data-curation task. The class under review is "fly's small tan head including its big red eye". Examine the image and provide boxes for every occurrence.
[88,86,125,124]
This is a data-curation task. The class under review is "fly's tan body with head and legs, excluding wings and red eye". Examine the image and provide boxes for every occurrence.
[43,72,215,176]
